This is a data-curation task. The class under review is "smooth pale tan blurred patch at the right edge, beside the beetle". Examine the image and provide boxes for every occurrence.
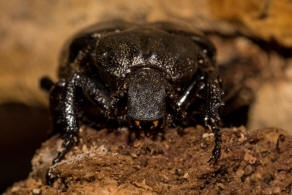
[249,79,292,134]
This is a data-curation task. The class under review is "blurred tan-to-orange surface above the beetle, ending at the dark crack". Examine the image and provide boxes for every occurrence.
[0,0,292,105]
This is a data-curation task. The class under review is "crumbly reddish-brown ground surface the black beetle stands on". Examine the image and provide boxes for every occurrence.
[5,126,292,194]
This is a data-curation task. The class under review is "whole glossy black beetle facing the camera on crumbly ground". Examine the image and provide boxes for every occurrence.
[41,21,223,184]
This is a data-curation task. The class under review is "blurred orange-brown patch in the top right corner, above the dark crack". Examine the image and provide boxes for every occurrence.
[209,0,292,47]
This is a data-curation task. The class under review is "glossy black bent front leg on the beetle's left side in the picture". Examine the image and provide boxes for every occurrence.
[47,73,111,185]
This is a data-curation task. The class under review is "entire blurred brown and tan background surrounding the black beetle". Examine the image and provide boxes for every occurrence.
[0,0,292,192]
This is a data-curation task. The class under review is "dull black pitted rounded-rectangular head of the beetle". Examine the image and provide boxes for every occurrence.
[128,68,166,121]
